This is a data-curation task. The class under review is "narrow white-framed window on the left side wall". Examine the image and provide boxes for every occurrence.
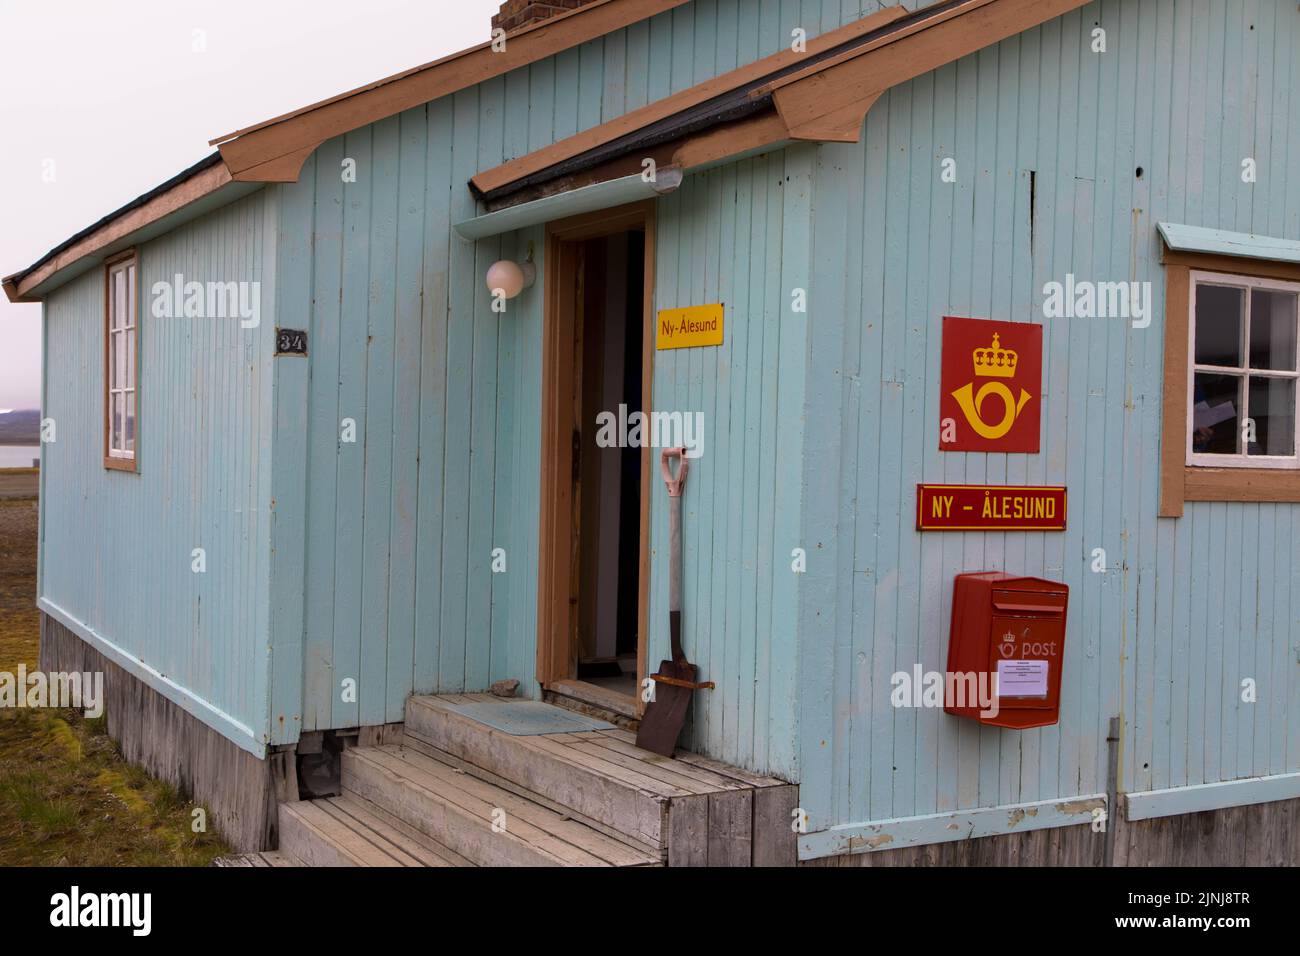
[104,252,139,471]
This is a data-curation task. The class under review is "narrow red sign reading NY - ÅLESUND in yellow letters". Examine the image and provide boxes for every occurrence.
[917,485,1065,531]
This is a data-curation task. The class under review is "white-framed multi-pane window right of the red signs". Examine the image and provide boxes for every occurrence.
[1187,271,1300,468]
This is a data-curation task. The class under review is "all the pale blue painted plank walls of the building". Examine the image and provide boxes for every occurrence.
[42,0,1300,830]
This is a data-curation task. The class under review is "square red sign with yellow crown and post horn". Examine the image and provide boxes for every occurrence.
[939,316,1043,453]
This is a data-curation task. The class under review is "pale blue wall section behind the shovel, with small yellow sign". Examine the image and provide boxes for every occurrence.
[649,146,816,778]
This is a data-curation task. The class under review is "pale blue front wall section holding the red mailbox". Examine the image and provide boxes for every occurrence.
[800,0,1300,830]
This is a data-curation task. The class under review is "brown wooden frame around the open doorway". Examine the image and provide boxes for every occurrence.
[537,200,655,717]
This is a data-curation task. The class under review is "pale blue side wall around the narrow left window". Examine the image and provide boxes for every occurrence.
[40,191,276,750]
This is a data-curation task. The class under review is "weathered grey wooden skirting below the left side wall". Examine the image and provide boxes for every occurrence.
[40,613,282,852]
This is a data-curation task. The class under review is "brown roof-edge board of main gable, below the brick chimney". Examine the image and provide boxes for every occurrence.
[211,0,688,182]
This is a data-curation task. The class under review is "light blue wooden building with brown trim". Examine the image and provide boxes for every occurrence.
[5,0,1300,864]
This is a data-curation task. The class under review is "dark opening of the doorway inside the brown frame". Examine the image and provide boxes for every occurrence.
[569,230,645,696]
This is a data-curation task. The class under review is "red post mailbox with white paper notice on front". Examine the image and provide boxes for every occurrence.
[944,571,1070,730]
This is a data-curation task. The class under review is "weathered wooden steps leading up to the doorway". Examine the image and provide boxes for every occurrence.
[258,695,798,866]
